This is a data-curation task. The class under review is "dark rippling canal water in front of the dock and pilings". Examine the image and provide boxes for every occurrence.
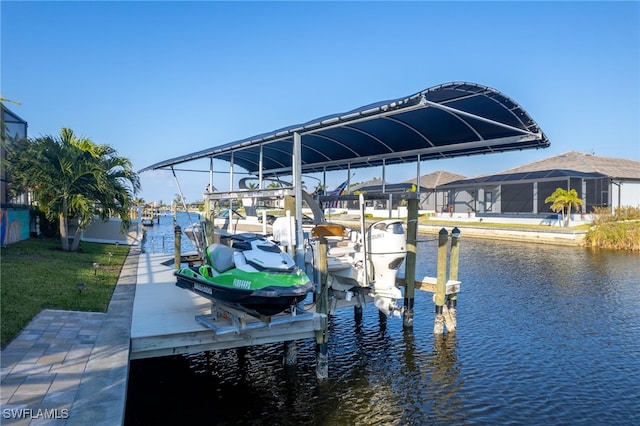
[125,215,640,425]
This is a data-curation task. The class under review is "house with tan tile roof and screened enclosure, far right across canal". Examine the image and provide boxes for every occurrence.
[440,151,640,218]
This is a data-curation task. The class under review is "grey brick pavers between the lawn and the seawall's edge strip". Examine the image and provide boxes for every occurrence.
[0,309,106,425]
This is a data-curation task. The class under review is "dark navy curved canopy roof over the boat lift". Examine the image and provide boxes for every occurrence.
[141,82,549,175]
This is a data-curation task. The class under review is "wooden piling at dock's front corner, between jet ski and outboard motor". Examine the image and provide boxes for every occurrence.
[315,236,329,380]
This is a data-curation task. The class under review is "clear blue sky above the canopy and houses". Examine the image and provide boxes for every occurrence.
[0,0,640,202]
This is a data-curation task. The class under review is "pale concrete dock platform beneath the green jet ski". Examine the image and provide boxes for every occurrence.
[130,255,322,359]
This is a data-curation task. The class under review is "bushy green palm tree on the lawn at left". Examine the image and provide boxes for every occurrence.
[8,128,140,251]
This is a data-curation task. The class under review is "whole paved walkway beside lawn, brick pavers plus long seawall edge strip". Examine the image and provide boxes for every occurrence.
[0,246,140,426]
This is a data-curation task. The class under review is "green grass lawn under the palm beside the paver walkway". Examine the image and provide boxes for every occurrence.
[0,239,129,347]
